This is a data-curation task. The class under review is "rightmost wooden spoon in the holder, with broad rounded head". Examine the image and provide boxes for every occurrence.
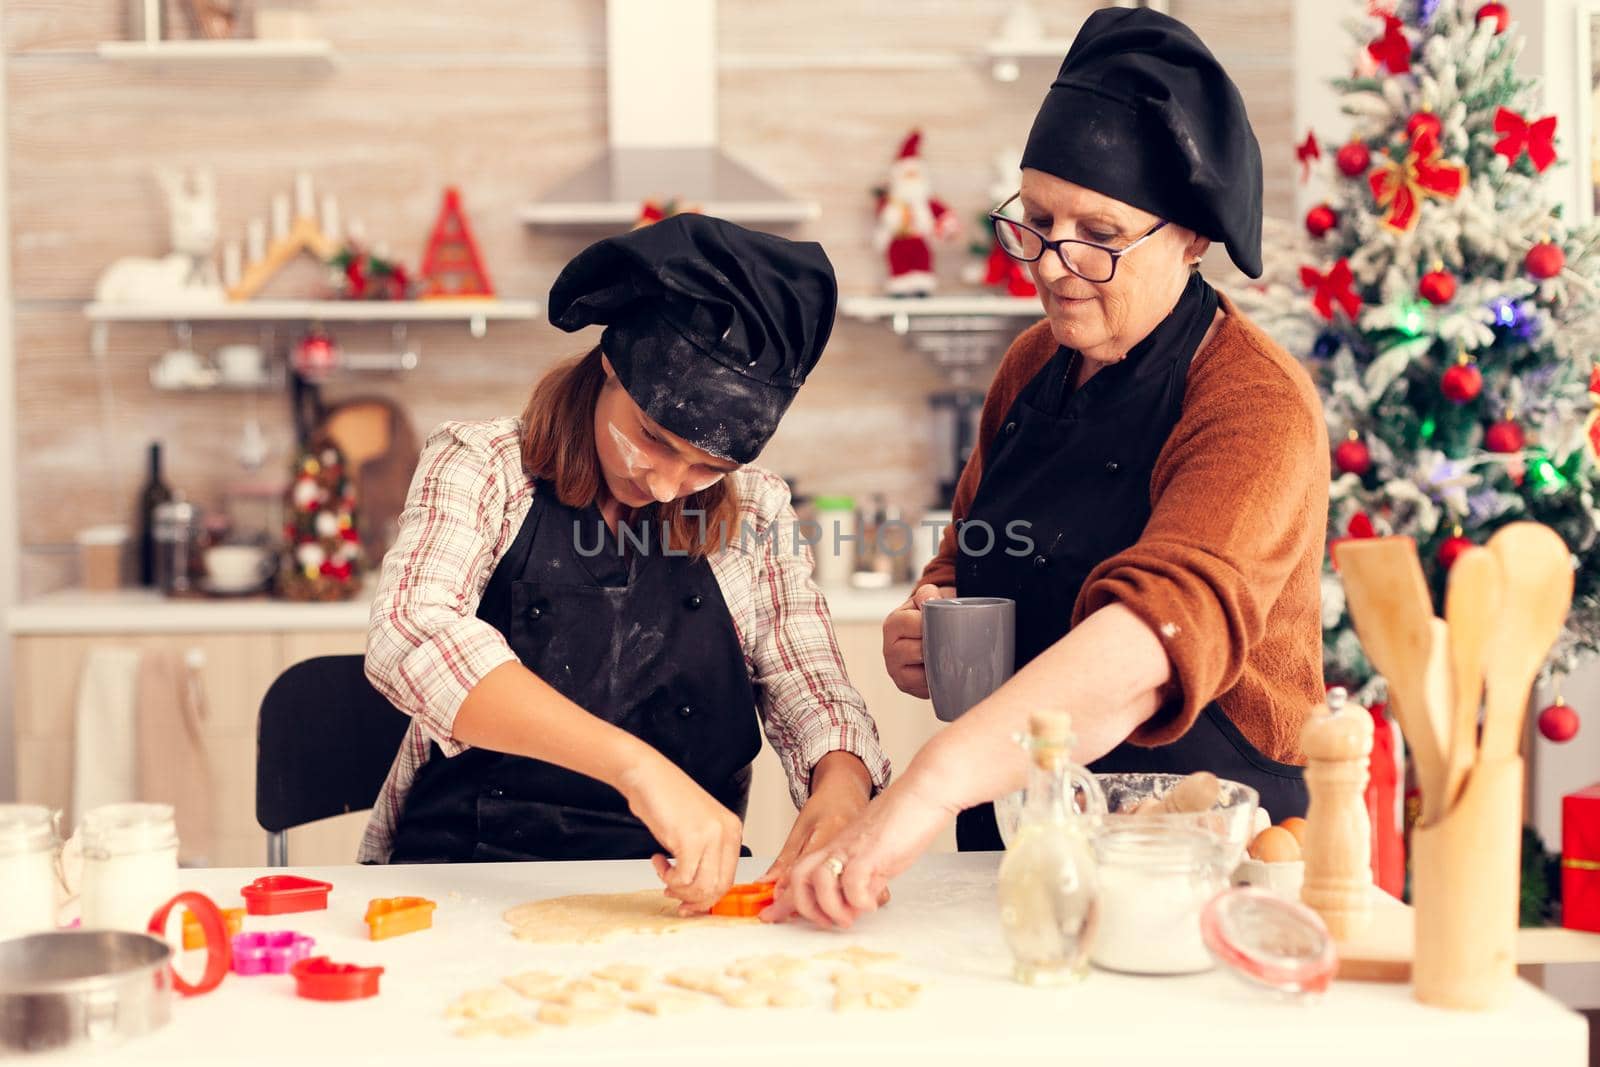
[1478,523,1573,763]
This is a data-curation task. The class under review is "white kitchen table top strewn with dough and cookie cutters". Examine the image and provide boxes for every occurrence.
[26,854,1587,1067]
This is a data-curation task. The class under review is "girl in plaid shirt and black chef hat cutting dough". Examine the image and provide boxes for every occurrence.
[362,214,888,910]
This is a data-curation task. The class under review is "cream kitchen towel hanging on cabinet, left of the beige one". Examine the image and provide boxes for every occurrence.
[70,645,139,825]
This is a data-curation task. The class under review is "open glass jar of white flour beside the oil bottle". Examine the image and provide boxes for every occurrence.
[1090,821,1227,974]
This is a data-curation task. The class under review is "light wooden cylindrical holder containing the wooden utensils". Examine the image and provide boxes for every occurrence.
[1411,758,1523,1011]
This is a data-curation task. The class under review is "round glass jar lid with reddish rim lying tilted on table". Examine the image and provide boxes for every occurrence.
[1200,886,1339,993]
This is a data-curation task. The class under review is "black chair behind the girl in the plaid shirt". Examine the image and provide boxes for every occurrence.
[256,656,411,867]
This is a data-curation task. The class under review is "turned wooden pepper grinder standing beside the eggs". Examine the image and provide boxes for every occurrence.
[1301,688,1373,941]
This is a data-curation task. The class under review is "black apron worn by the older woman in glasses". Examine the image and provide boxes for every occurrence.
[955,274,1307,851]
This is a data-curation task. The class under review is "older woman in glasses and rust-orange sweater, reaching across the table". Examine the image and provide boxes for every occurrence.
[768,8,1328,925]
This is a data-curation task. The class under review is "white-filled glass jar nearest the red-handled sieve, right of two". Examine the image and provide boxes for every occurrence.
[78,805,178,933]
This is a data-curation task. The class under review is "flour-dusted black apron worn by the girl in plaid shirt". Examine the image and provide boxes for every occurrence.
[389,483,762,864]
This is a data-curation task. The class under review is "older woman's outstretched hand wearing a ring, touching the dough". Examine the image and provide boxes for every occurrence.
[762,771,957,928]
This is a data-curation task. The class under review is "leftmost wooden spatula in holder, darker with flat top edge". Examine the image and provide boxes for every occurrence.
[1333,537,1445,821]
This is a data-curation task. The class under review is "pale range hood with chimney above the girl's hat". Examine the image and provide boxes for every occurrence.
[520,0,818,226]
